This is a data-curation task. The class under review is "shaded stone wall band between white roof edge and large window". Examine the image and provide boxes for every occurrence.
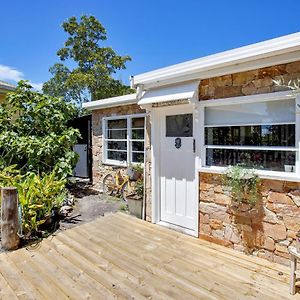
[199,61,300,100]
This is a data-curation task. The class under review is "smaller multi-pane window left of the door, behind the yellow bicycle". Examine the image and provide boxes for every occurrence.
[103,115,145,165]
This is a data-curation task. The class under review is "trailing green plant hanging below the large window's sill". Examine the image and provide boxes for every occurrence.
[225,165,260,205]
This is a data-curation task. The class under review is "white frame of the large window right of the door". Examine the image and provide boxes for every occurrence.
[198,91,300,182]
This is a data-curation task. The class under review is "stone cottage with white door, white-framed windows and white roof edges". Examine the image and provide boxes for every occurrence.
[84,33,300,263]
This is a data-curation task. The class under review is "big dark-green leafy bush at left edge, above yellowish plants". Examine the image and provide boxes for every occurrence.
[0,81,80,178]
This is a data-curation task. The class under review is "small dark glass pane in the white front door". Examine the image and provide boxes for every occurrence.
[166,114,193,137]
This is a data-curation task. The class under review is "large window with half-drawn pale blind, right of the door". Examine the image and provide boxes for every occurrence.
[204,99,298,172]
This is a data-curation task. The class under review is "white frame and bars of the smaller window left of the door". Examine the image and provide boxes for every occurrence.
[102,114,146,167]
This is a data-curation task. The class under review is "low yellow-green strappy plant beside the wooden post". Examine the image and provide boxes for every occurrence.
[0,166,66,238]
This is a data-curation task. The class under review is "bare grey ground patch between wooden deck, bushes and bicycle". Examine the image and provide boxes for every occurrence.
[59,183,126,230]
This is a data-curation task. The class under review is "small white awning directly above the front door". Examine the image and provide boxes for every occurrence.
[138,80,199,105]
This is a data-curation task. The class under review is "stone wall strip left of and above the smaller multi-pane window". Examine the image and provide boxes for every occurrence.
[92,104,145,189]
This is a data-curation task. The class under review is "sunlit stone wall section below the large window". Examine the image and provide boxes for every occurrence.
[199,173,300,264]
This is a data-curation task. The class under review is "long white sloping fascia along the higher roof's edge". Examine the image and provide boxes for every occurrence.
[133,32,300,86]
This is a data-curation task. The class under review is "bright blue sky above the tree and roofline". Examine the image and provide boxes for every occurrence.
[0,0,300,87]
